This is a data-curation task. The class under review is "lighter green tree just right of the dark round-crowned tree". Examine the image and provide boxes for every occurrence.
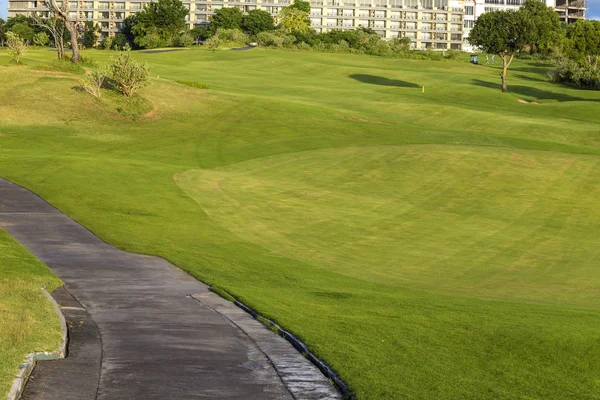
[520,0,561,54]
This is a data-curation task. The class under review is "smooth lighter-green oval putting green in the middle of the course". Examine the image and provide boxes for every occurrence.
[176,145,600,307]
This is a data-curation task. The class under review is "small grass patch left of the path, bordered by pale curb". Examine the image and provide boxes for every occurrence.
[0,230,61,399]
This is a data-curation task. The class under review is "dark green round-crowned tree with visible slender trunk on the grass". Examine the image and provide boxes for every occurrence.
[469,10,532,92]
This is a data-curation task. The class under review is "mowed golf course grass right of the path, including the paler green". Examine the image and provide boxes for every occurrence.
[0,49,600,400]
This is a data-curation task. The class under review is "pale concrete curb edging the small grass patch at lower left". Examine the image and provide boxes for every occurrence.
[6,287,69,400]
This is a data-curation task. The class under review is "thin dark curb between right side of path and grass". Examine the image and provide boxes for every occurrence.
[209,286,356,400]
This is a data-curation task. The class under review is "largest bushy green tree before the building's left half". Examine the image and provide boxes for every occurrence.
[132,0,189,48]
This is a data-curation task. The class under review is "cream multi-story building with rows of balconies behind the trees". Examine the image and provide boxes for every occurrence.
[8,0,585,51]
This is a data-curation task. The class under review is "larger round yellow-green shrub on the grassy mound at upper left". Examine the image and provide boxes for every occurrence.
[108,51,150,97]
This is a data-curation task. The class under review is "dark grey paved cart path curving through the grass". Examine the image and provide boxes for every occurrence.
[0,178,335,400]
